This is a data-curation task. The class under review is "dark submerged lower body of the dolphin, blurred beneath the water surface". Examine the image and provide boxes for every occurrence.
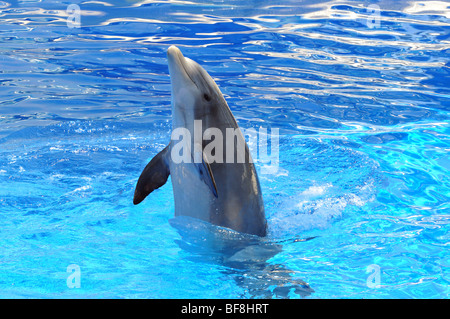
[169,216,314,299]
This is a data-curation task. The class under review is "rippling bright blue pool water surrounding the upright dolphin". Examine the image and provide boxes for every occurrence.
[0,0,450,298]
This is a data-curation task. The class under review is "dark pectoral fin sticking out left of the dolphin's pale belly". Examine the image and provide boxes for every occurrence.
[133,146,170,205]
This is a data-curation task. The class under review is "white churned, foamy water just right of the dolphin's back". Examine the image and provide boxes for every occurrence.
[261,137,381,238]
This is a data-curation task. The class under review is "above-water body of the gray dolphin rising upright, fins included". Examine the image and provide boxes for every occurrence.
[133,46,267,236]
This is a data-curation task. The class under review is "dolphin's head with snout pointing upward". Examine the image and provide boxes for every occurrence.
[167,45,226,123]
